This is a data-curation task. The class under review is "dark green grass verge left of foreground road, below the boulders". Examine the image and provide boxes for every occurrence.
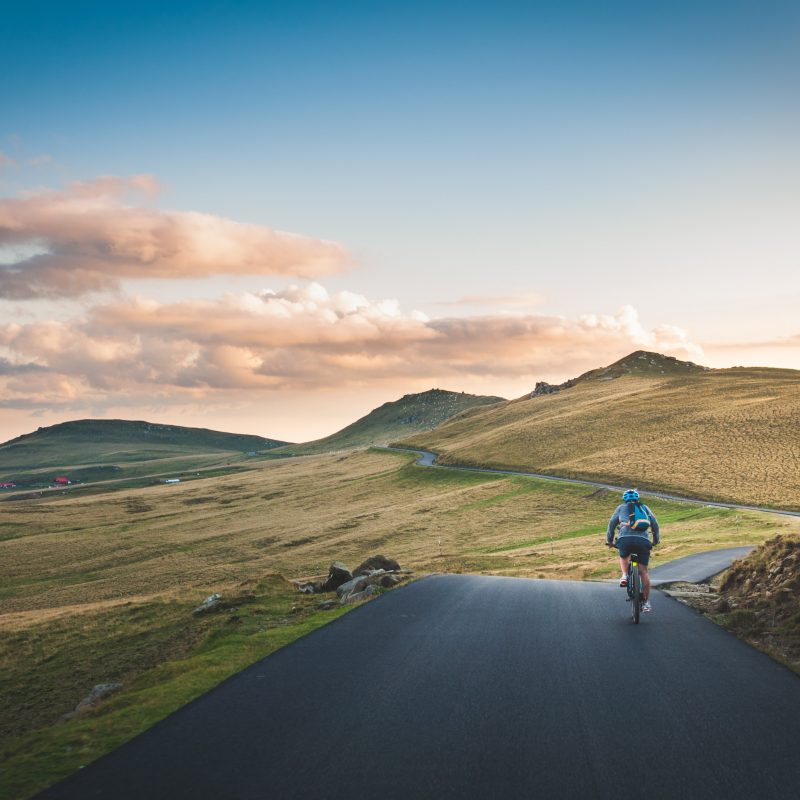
[0,576,352,800]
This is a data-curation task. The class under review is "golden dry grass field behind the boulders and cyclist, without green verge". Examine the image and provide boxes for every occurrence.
[0,451,789,623]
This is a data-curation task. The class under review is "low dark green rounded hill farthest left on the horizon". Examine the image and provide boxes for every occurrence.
[0,419,286,488]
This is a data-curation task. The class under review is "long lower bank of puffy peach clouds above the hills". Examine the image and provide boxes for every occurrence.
[0,283,702,407]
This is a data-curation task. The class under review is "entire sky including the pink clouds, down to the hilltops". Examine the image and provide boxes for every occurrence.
[0,0,800,441]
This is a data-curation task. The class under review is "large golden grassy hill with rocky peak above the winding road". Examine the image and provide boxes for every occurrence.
[403,353,800,509]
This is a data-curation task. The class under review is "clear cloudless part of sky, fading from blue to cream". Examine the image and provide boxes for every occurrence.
[0,1,800,438]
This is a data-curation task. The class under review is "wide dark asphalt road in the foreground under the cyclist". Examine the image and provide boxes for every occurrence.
[42,575,800,800]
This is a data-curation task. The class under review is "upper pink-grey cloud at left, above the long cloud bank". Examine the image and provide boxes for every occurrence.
[0,175,349,299]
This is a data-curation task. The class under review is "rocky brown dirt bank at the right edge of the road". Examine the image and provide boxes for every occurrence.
[670,536,800,673]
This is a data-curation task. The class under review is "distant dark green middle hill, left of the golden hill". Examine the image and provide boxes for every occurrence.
[277,389,503,455]
